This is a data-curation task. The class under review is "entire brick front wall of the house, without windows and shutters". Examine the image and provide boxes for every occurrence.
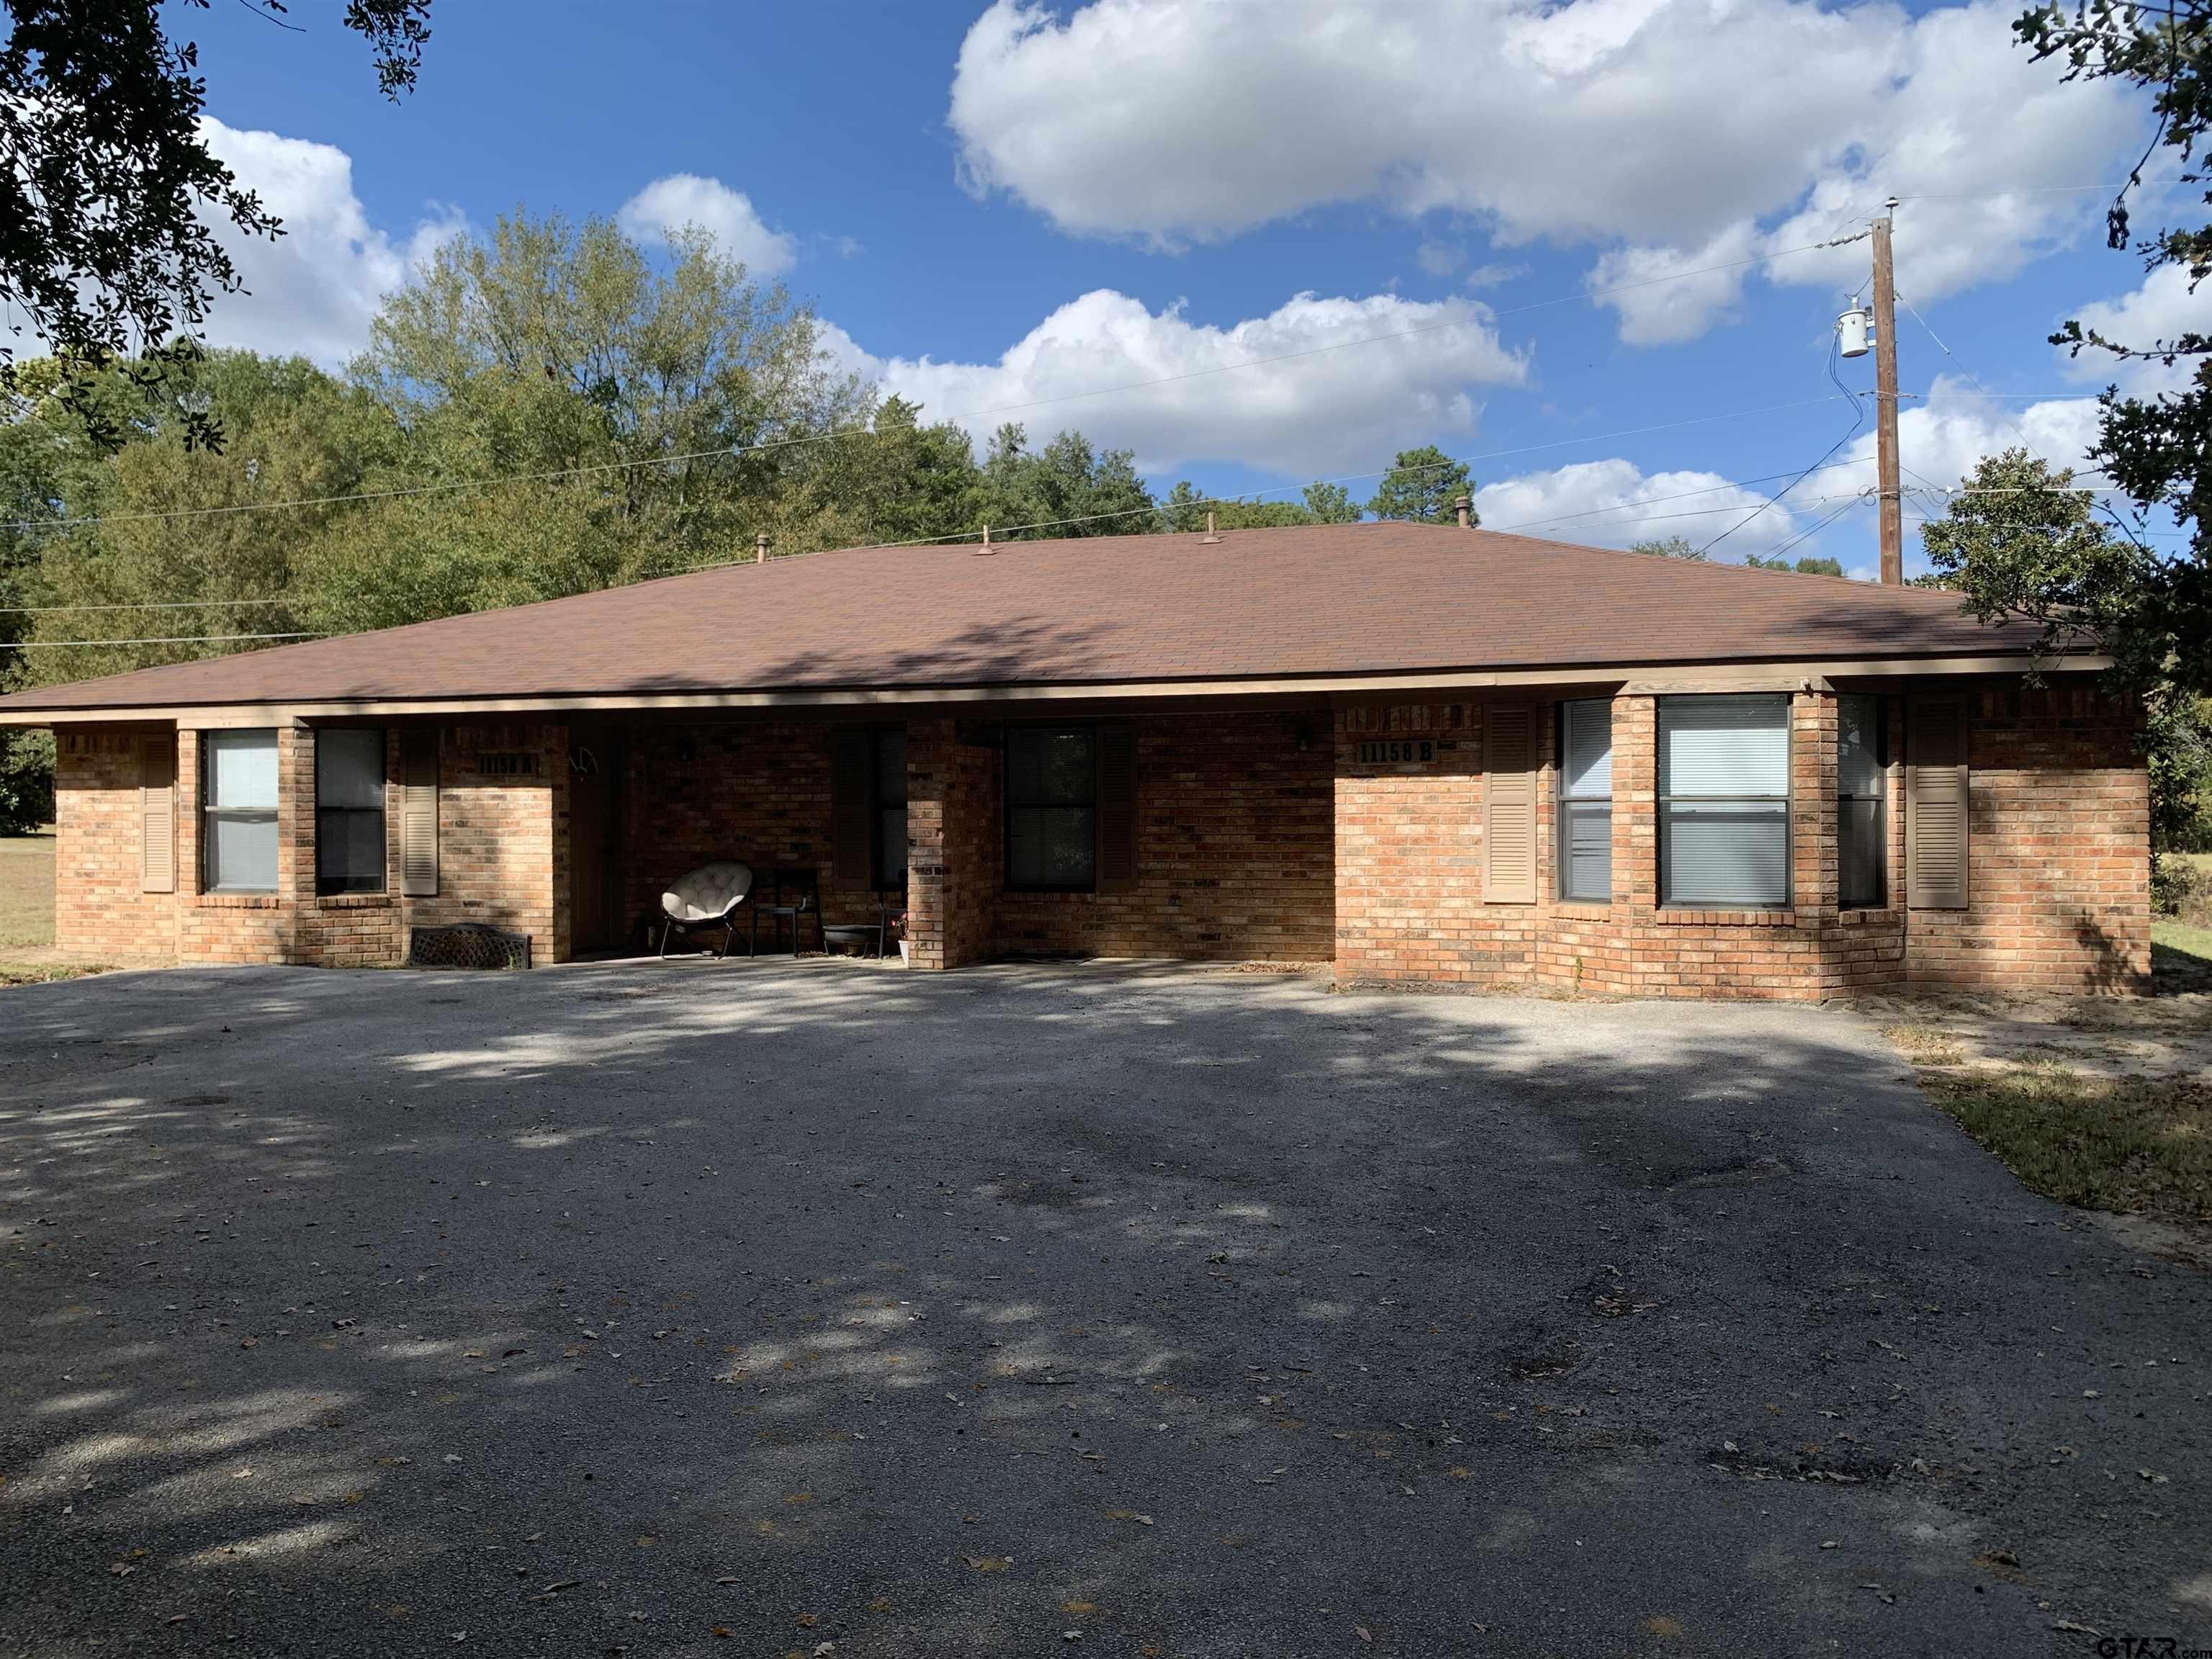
[35,679,2150,997]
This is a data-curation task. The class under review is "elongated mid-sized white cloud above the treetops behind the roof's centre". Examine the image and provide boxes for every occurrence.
[827,287,1527,475]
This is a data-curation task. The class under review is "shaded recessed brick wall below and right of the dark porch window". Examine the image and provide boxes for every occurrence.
[999,714,1336,962]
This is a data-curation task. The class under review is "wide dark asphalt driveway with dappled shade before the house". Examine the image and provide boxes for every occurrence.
[0,960,2212,1659]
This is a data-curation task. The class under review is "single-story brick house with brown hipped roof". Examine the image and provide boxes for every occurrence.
[0,524,2150,997]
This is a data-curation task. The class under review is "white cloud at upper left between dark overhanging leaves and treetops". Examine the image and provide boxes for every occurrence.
[202,117,464,369]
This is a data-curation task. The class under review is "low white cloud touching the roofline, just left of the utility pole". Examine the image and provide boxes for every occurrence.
[1475,458,1822,557]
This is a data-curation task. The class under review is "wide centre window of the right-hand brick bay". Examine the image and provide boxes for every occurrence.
[1659,697,1789,909]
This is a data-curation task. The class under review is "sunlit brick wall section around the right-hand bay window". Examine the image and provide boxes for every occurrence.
[1336,679,2150,997]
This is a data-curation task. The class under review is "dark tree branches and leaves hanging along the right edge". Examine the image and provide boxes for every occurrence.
[2017,0,2212,697]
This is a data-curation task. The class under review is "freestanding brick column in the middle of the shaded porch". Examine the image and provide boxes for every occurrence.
[907,721,1000,969]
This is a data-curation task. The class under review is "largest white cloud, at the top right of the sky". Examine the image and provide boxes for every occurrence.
[949,0,2141,341]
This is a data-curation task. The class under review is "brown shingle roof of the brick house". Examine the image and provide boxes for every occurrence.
[0,524,2033,712]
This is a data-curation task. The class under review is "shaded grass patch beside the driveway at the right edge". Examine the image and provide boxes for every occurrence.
[1920,1062,2212,1221]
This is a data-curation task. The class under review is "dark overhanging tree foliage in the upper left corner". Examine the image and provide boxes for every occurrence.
[0,0,429,442]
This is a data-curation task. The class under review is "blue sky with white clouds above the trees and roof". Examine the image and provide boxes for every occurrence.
[173,0,2201,571]
